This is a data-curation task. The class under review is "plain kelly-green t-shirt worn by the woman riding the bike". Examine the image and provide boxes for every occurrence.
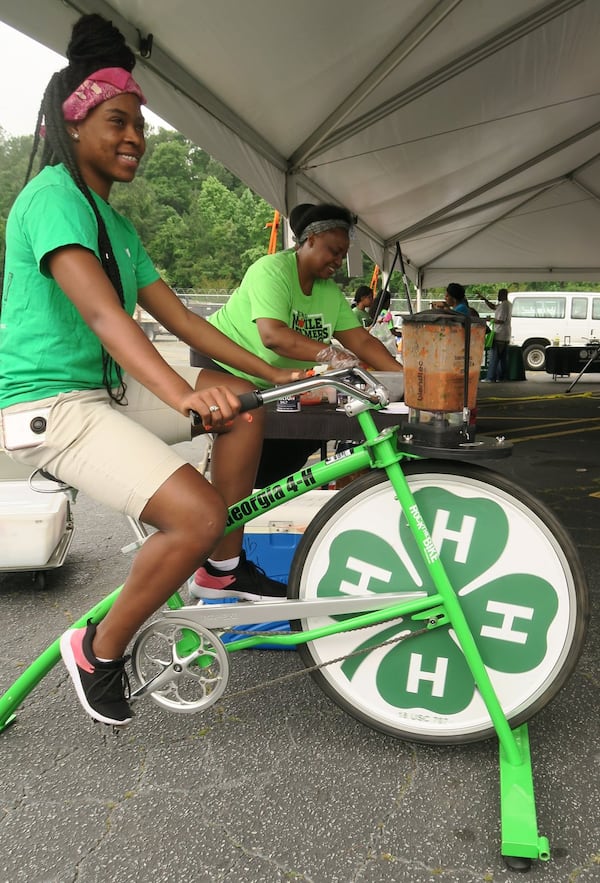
[0,165,159,408]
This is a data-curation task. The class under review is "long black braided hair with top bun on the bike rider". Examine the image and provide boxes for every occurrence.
[24,14,135,404]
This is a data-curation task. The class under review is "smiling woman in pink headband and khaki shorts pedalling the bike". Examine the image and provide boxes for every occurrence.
[0,15,304,726]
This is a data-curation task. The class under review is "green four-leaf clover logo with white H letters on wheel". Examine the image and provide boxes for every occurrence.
[317,487,559,716]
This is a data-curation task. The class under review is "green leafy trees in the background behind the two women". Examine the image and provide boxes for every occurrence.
[0,128,600,300]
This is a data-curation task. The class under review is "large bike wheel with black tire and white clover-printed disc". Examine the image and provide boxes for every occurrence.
[288,460,589,744]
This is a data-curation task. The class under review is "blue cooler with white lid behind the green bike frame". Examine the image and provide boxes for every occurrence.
[244,490,336,583]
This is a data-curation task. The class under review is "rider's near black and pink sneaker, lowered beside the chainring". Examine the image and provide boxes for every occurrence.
[60,620,132,727]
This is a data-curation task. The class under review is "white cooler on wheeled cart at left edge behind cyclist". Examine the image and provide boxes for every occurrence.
[0,481,68,570]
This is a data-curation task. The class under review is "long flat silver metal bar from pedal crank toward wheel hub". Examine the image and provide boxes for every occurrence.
[169,592,427,628]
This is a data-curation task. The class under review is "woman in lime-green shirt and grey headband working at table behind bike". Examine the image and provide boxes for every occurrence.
[189,204,402,520]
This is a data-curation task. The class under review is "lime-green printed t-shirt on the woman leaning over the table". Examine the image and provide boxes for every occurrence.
[208,250,360,388]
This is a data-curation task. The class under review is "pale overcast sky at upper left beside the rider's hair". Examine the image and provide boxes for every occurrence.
[0,20,167,136]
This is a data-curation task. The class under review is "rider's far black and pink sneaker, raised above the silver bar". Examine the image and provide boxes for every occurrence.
[188,550,287,601]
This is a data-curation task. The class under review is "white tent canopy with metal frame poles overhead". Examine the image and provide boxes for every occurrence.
[0,0,600,288]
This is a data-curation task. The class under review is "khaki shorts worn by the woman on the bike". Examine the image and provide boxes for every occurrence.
[0,366,199,518]
